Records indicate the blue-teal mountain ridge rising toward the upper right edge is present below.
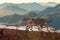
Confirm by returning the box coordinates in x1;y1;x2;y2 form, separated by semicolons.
39;4;60;15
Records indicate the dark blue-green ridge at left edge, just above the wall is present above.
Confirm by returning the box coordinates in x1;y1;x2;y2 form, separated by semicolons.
0;14;23;23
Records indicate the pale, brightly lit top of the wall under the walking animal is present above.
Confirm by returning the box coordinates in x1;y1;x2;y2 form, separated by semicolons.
0;25;60;33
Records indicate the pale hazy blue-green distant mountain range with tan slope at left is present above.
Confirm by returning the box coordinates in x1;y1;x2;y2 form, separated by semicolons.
0;2;57;16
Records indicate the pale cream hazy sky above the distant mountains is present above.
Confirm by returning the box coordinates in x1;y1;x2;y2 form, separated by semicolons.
0;0;60;3
